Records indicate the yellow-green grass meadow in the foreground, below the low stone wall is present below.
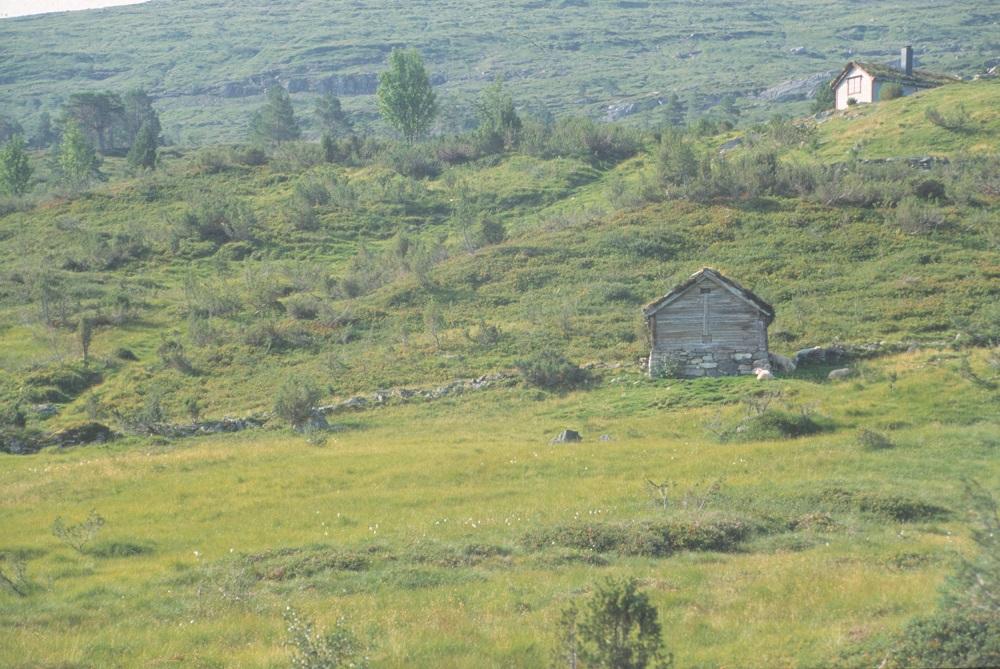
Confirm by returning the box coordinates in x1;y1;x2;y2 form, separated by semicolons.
0;350;1000;667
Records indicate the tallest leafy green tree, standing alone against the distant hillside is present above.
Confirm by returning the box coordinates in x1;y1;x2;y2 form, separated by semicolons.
378;49;438;143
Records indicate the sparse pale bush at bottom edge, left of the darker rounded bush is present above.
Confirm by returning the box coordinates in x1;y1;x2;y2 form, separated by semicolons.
285;607;368;669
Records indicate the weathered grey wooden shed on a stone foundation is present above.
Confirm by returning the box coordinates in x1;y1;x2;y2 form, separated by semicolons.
643;267;774;377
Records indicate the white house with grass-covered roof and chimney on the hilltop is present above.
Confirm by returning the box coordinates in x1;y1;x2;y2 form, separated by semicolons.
830;46;956;109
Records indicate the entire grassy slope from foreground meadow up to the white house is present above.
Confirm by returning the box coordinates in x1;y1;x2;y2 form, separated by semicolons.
0;74;1000;667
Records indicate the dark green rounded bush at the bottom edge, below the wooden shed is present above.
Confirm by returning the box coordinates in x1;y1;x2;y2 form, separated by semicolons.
555;578;673;669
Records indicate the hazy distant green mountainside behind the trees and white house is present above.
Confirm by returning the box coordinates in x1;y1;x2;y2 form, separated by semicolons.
0;0;1000;145
